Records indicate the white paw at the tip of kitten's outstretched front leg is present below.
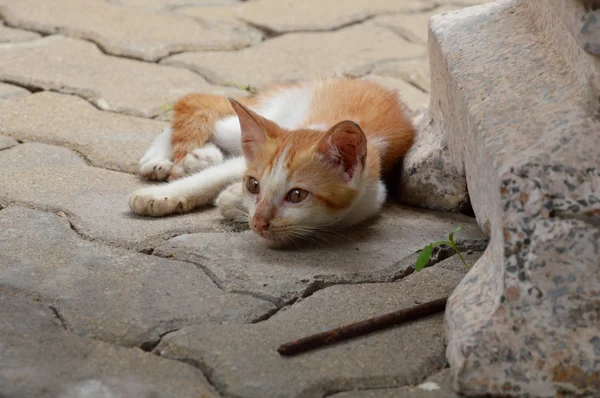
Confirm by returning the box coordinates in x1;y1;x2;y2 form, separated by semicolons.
129;185;194;217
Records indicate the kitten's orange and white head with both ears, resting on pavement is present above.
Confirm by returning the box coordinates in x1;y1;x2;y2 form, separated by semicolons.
232;100;367;243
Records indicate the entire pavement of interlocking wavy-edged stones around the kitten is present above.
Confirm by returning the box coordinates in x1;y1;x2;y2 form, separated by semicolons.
0;0;487;398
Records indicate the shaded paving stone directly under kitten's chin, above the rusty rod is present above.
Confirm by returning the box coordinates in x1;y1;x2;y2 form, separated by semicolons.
155;205;486;301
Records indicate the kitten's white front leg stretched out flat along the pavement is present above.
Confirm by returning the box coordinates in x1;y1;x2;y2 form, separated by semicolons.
129;157;246;217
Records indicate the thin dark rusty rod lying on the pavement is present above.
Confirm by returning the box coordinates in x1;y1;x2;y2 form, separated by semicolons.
277;297;448;357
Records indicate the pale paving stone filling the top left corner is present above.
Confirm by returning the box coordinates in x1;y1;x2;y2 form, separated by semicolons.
0;0;262;61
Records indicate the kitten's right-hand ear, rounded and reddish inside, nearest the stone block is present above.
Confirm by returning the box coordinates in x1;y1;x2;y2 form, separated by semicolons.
318;120;367;179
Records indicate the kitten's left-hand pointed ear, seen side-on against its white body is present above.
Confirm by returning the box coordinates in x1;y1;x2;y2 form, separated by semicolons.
229;98;278;161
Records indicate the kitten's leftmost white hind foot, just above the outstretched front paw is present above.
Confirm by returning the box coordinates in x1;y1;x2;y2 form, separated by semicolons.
139;128;173;181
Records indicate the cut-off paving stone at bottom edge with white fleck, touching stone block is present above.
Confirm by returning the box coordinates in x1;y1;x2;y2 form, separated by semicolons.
332;369;459;398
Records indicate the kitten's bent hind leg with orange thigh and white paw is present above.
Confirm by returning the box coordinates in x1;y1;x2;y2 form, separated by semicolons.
169;94;235;180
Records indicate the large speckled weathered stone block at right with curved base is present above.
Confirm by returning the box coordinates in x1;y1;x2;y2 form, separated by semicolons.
430;1;600;397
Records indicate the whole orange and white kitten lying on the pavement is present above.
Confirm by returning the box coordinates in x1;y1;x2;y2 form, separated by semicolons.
129;78;415;243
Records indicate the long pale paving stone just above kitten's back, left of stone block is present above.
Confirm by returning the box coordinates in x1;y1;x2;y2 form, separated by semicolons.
162;24;425;87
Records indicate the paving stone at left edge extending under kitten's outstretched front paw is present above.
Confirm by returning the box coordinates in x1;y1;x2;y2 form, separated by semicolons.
0;143;237;250
